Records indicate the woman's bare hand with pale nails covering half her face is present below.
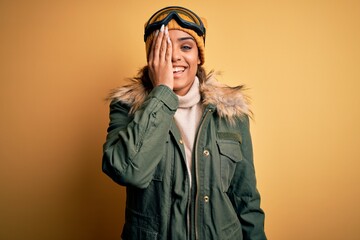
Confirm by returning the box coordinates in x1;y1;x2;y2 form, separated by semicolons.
148;25;174;89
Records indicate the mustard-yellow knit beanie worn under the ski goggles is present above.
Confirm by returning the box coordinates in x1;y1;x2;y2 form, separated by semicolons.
145;7;207;65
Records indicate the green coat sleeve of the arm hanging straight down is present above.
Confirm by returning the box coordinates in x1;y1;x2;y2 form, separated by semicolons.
228;117;266;240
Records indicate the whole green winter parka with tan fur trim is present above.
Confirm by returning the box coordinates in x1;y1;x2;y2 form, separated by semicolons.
102;77;266;240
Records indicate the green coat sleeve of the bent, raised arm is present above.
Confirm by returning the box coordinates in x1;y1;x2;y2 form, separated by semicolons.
102;85;178;188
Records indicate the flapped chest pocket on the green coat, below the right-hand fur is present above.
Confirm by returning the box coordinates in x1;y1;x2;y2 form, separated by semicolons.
217;140;243;192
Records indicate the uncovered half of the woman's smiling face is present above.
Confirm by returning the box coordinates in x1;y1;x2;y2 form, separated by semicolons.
169;30;200;96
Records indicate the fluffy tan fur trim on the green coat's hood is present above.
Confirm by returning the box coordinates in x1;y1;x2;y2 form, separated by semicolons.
108;74;252;122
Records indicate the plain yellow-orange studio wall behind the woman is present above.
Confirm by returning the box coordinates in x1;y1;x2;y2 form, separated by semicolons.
0;0;360;240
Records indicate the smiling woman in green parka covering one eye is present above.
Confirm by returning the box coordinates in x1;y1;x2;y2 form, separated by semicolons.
103;7;266;240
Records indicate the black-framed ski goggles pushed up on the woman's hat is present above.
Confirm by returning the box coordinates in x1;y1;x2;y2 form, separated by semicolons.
144;6;206;44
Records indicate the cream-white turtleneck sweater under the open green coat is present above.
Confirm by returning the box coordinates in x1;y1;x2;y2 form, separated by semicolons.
174;77;203;186
